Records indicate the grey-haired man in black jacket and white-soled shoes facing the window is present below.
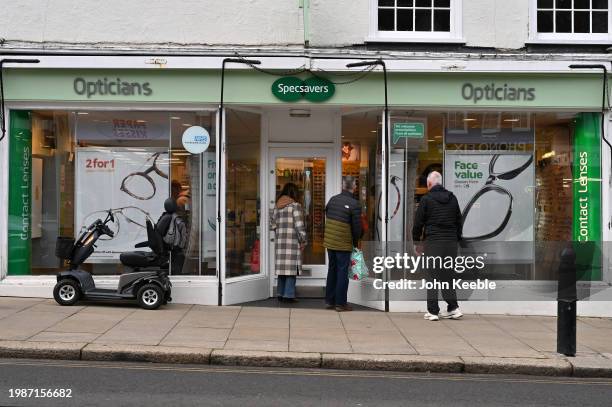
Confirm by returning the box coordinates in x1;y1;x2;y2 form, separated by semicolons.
412;171;463;321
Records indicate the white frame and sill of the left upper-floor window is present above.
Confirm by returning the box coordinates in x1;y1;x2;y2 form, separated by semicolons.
366;0;465;43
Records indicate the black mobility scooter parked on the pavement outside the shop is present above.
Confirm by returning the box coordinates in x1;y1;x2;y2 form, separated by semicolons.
53;210;172;310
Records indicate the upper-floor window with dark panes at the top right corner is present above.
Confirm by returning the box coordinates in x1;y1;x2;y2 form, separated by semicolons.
530;0;612;43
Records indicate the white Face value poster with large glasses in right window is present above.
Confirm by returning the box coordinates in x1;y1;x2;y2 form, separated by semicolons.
444;151;534;260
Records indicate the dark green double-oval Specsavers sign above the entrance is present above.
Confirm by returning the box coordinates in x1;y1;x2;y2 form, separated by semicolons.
272;76;336;102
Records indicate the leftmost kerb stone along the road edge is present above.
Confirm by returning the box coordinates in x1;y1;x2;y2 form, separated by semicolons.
0;341;86;360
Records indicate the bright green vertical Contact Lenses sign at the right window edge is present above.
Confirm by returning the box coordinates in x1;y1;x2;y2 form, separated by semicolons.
572;113;602;281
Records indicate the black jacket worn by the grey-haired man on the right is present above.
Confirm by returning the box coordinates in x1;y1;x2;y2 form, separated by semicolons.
412;185;462;242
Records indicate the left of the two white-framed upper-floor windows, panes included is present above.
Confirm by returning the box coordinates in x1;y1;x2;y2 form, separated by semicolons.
369;0;461;42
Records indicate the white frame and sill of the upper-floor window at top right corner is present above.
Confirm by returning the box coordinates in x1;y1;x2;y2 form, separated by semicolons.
528;0;612;44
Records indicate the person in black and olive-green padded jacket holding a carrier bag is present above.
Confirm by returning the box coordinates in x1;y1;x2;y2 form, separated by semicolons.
323;176;362;312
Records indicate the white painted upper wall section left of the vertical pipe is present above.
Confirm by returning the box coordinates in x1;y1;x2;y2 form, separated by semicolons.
0;0;304;45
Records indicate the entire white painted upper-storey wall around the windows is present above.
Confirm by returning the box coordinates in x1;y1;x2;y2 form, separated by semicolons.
0;0;529;49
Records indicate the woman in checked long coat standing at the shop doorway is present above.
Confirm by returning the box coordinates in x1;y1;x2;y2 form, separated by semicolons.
270;182;307;302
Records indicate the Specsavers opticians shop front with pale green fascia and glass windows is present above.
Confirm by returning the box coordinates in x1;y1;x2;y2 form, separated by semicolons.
0;57;610;314
